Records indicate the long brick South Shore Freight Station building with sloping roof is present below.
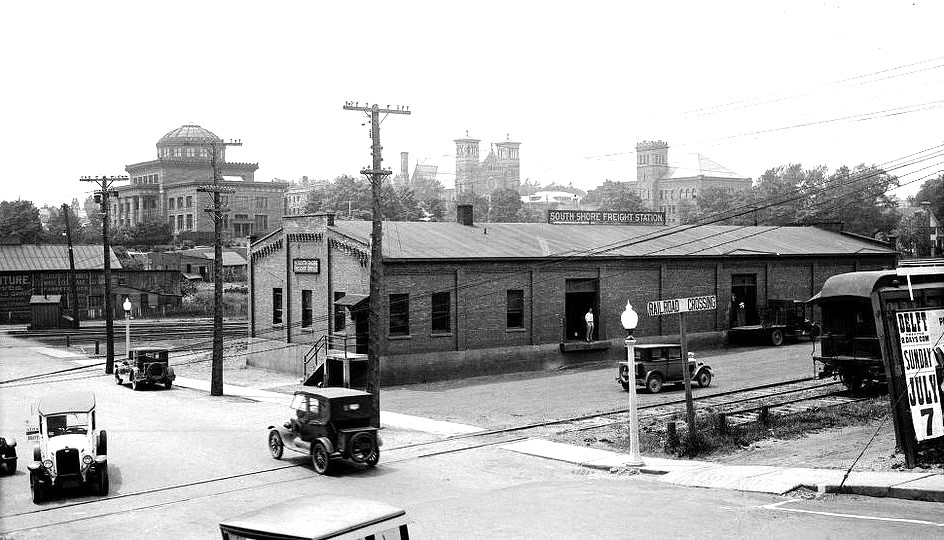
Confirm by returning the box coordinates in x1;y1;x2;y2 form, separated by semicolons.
249;207;897;384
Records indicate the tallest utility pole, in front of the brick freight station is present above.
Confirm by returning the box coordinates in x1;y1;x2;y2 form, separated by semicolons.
344;101;410;427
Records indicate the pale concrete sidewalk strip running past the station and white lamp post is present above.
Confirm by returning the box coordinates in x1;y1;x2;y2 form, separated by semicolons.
175;377;944;502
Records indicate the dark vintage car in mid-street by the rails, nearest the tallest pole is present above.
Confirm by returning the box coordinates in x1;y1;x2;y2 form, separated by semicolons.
268;387;381;474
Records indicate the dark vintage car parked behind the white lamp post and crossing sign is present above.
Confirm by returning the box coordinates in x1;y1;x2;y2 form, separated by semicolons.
616;343;714;394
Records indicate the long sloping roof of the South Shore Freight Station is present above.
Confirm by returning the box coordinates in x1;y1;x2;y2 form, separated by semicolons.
329;220;896;260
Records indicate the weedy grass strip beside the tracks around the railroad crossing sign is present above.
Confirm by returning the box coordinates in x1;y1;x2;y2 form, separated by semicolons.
581;396;888;458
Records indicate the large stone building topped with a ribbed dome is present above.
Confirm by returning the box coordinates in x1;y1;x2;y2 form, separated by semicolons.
110;124;288;243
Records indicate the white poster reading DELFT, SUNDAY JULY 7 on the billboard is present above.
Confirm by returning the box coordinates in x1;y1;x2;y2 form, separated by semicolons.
895;309;944;441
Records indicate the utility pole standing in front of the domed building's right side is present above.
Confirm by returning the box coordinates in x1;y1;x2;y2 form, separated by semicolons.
197;137;242;396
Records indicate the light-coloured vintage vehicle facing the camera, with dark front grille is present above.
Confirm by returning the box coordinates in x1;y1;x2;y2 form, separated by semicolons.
27;392;108;503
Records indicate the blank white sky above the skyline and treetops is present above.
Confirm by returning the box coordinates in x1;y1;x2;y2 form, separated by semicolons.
0;0;944;206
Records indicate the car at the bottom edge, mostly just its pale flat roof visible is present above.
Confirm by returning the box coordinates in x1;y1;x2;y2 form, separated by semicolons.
220;495;410;540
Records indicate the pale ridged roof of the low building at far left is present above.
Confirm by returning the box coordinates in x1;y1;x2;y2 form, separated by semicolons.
0;244;121;272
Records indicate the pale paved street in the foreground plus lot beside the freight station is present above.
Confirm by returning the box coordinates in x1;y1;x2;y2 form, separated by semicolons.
0;341;944;538
